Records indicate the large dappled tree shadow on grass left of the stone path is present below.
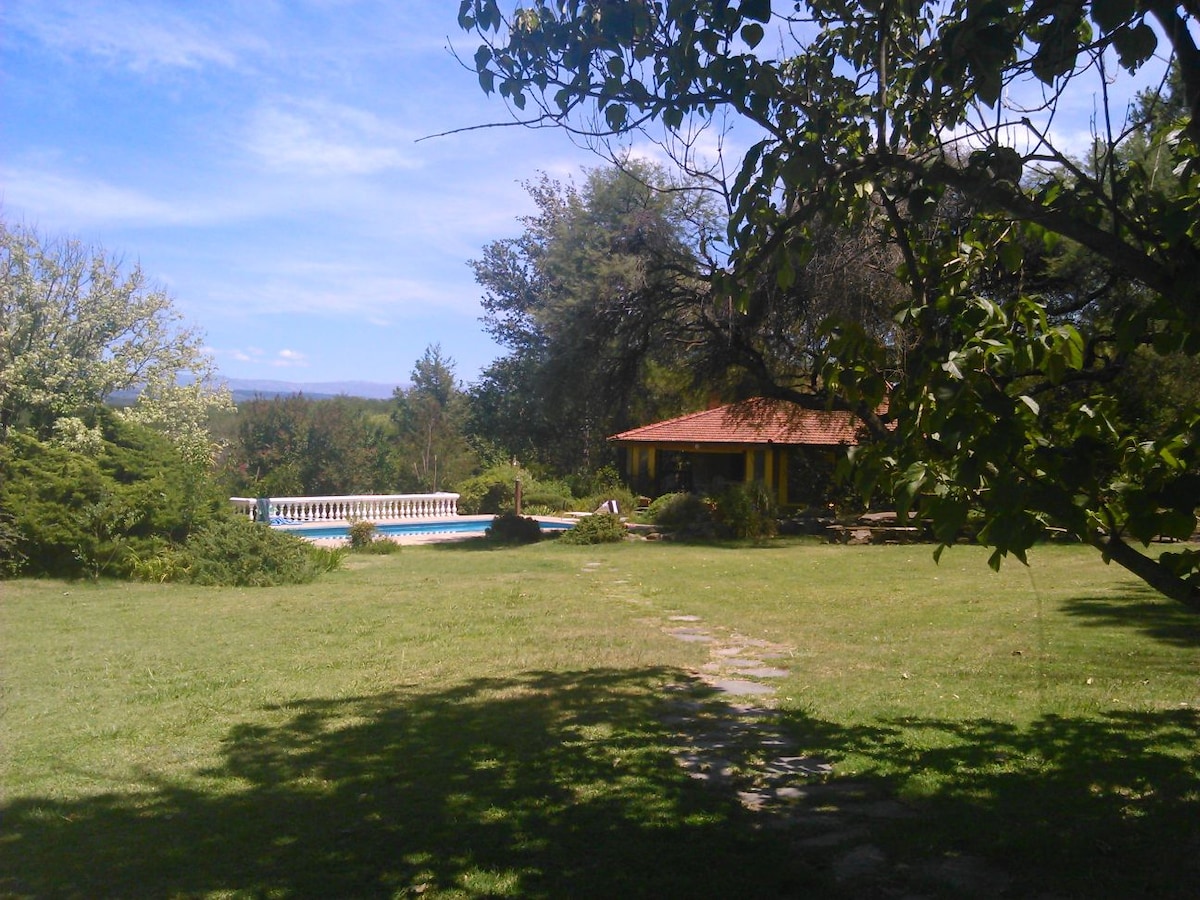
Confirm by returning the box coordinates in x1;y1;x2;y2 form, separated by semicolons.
0;670;828;898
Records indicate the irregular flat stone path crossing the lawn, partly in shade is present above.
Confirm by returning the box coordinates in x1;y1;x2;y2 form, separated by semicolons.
586;564;1010;900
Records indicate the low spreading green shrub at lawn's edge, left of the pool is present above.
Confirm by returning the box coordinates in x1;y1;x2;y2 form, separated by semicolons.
176;516;341;587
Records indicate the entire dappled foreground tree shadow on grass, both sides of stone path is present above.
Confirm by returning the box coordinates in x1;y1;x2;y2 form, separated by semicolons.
0;668;1200;898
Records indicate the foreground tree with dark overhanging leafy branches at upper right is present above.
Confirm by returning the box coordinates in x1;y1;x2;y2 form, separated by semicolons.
460;0;1200;610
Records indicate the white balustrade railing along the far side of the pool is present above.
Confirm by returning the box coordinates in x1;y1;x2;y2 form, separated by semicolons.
229;492;458;523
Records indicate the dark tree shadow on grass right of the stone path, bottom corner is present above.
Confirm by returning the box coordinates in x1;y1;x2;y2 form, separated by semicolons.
777;709;1200;898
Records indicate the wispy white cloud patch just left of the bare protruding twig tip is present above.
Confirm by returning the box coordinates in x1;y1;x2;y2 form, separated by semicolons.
246;101;420;175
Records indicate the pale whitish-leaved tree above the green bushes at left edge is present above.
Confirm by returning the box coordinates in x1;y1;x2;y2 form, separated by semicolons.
0;220;229;464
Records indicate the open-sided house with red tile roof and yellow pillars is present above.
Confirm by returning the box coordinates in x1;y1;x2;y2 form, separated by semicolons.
608;397;863;508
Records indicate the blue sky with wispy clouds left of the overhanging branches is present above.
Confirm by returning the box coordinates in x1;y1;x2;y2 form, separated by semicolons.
0;0;599;383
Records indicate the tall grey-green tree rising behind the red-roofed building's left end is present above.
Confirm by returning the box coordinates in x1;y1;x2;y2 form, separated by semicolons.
472;156;719;472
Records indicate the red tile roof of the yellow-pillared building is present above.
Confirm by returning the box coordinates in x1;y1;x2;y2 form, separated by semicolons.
608;397;862;446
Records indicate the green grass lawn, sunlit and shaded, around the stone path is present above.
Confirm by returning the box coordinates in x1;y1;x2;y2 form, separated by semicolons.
0;540;1200;898
